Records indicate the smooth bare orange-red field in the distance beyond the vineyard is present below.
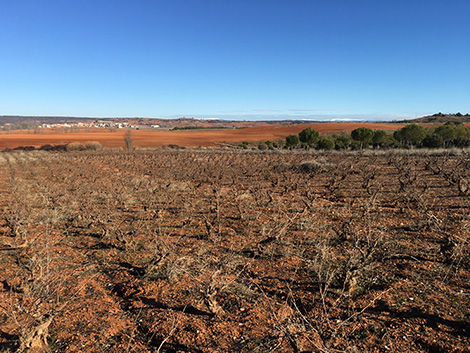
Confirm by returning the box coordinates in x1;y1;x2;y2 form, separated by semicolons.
0;123;403;150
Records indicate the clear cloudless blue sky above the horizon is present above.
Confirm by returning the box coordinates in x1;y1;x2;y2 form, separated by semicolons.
0;0;470;120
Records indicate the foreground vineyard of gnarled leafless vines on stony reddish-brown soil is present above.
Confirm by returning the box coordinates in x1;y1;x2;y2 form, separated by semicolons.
0;147;470;353
